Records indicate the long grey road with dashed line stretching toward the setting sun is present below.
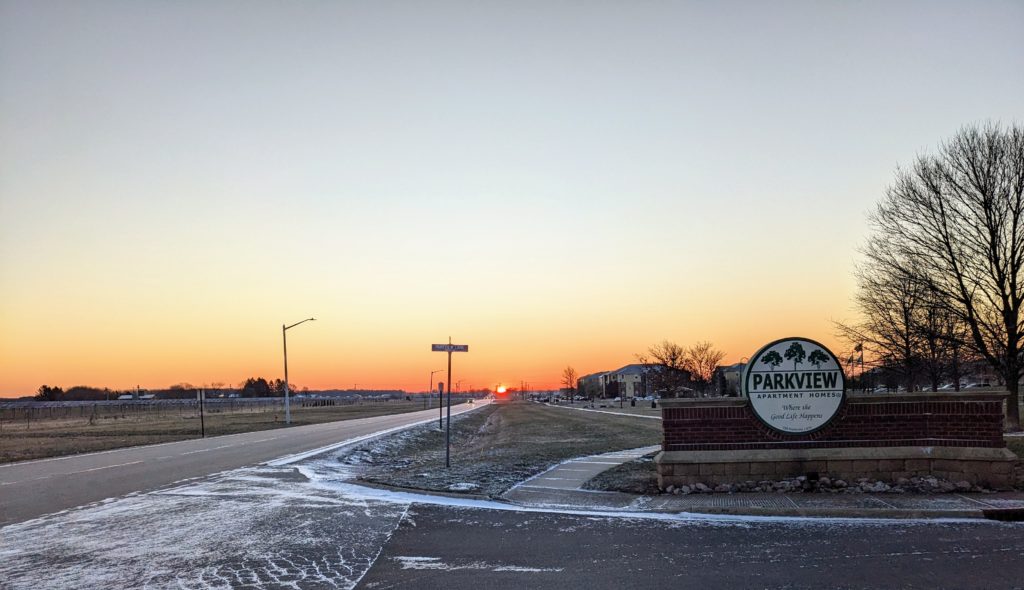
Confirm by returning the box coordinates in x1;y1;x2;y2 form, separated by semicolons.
0;404;480;526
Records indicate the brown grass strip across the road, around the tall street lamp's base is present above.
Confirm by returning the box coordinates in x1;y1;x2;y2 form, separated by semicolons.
0;401;446;463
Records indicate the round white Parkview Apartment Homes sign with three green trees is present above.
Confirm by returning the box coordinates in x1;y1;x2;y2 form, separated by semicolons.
743;338;846;434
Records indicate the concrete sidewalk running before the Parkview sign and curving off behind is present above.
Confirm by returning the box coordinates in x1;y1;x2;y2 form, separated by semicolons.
504;447;1024;519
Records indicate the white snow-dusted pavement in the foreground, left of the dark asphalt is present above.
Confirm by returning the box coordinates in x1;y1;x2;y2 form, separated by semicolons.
0;468;408;589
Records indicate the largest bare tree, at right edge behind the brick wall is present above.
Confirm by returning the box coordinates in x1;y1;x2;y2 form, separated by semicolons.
868;125;1024;430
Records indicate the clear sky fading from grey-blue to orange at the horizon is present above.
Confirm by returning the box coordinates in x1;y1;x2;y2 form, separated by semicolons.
0;0;1024;396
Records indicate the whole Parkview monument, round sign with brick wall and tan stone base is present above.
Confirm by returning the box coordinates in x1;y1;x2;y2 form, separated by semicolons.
654;338;1017;489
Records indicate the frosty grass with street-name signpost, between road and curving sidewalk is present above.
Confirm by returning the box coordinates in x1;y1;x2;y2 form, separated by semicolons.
350;403;662;496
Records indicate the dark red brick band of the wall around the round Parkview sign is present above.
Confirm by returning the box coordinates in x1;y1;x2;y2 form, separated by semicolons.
662;393;1006;451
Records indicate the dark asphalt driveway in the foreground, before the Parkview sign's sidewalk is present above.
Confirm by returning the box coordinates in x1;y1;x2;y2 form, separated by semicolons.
356;504;1024;590
